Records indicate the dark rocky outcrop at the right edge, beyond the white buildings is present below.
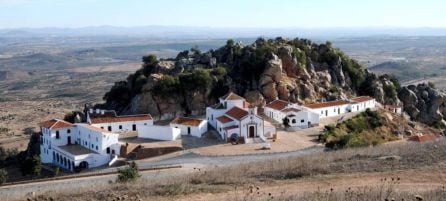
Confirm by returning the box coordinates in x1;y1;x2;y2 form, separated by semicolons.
398;84;446;127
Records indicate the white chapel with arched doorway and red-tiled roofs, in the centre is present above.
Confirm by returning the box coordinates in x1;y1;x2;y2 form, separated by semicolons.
206;92;276;142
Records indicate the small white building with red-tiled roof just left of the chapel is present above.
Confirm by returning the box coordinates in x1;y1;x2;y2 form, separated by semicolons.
170;117;208;137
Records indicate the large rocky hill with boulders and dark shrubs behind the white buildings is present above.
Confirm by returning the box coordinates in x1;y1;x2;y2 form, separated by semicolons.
99;37;446;127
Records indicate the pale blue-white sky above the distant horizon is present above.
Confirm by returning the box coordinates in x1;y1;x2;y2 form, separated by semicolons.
0;0;446;29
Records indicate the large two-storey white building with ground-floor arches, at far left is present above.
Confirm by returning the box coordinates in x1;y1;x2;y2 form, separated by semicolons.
40;119;121;171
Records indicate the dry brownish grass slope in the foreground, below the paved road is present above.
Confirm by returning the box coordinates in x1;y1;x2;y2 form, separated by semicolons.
19;139;446;201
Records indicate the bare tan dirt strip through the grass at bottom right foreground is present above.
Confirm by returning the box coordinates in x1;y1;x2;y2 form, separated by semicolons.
173;170;446;201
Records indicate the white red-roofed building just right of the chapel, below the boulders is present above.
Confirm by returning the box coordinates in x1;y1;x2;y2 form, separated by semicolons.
264;100;319;128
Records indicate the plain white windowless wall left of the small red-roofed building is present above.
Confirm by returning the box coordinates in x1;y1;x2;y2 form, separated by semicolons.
138;126;181;140
